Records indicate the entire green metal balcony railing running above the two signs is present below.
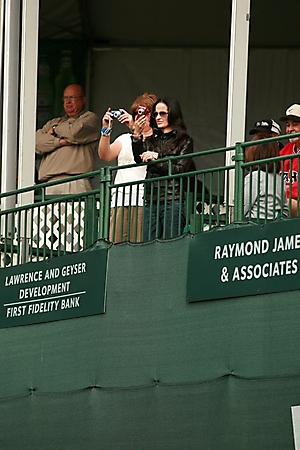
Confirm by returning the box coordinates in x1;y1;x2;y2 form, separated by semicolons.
0;133;300;267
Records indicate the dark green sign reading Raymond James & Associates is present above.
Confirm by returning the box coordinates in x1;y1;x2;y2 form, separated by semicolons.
187;219;300;302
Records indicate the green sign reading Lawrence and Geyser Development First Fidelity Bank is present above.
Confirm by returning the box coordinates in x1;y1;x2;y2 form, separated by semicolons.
0;249;107;328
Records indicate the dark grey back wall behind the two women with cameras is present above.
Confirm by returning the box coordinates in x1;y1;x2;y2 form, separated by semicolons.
90;48;300;190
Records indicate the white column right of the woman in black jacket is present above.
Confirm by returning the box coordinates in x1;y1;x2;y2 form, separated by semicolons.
225;0;251;206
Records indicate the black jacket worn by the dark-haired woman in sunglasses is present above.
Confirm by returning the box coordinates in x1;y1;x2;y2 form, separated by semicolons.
132;130;194;201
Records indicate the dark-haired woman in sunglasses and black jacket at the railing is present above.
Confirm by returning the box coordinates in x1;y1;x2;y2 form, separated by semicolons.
132;97;194;240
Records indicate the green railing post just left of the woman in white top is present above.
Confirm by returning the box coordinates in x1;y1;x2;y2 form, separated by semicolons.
99;167;112;239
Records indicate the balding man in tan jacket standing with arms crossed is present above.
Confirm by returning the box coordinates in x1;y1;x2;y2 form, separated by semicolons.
35;84;100;195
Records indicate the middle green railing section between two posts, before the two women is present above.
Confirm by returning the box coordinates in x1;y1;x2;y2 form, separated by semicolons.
105;147;234;242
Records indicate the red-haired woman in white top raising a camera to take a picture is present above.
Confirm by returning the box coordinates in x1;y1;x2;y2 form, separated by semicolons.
98;92;157;242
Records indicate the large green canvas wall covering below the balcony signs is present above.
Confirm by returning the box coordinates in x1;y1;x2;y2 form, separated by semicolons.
0;236;300;450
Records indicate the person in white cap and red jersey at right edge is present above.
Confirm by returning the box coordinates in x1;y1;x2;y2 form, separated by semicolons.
280;104;300;217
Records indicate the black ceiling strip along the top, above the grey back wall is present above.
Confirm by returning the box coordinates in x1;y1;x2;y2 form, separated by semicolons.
40;0;300;48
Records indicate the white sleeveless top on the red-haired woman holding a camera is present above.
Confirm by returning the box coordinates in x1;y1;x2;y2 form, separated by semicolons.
111;133;147;208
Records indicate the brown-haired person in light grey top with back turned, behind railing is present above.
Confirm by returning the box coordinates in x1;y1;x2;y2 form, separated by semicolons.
244;133;289;219
